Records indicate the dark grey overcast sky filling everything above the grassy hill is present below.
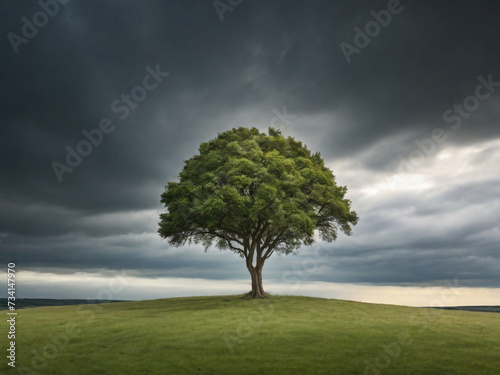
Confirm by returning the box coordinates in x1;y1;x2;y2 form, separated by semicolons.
0;0;500;305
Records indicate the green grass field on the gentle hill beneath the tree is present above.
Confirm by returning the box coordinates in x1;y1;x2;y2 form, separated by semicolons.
0;296;500;375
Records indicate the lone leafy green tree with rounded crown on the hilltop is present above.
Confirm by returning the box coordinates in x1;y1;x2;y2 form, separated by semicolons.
158;127;358;298
